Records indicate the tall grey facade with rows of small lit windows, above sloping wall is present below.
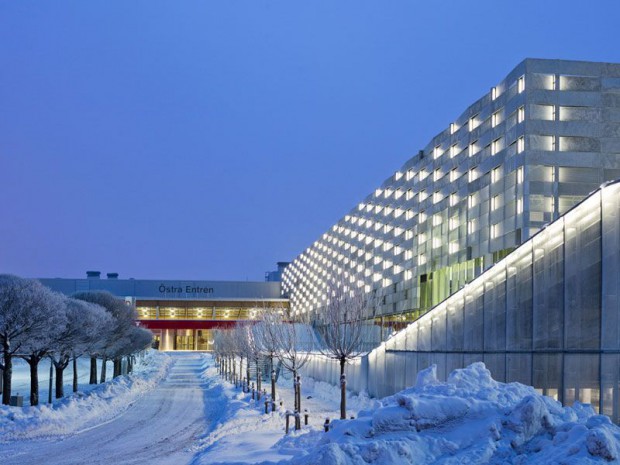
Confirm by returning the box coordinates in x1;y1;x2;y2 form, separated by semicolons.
283;59;620;325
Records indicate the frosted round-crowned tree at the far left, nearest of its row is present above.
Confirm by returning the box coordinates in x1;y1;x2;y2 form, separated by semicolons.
0;275;64;404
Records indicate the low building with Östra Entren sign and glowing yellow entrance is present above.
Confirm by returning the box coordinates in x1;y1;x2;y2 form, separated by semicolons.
39;271;288;350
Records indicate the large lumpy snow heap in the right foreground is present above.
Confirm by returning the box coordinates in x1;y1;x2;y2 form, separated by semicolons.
284;363;620;465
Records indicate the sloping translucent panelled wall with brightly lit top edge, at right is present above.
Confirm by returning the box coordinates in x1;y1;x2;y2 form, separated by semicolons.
308;183;620;422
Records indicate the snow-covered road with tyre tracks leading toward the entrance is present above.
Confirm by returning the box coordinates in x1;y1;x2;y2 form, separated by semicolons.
0;353;206;465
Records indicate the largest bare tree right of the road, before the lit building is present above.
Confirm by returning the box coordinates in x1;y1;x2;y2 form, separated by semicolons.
316;276;376;420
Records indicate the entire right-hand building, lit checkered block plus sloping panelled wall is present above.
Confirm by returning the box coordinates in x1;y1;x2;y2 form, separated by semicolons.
283;59;620;422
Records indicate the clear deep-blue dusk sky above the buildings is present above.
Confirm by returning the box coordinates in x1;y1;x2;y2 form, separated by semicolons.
0;0;620;280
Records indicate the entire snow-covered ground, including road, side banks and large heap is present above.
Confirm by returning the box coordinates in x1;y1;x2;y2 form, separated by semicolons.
0;352;620;465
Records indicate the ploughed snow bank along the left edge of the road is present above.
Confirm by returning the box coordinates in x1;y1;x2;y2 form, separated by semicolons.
0;351;172;442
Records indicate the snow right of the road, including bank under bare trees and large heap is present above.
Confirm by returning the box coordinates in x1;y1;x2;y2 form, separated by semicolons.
195;363;620;465
